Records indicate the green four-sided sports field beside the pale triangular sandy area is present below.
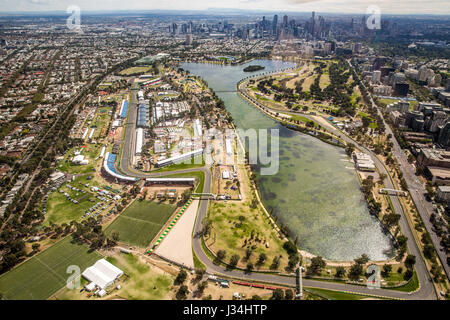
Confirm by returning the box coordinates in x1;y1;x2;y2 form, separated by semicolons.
105;200;175;248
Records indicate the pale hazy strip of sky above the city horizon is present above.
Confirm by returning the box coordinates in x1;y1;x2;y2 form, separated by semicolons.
0;0;450;14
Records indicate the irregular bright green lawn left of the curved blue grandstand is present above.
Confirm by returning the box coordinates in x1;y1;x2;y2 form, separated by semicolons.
43;183;99;226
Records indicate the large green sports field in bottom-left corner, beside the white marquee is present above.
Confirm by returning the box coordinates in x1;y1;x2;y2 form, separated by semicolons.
0;236;102;300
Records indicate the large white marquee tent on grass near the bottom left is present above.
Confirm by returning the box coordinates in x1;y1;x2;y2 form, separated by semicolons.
82;259;123;289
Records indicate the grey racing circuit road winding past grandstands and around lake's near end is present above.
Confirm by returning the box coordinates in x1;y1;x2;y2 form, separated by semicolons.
116;74;436;300
